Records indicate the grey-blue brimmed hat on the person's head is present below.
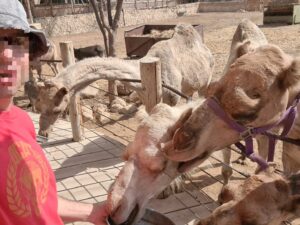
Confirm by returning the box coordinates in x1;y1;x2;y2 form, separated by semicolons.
0;0;49;58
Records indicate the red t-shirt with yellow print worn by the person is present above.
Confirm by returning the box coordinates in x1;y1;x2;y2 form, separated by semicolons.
0;106;63;225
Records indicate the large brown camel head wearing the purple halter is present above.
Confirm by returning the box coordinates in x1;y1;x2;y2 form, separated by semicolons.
164;45;300;161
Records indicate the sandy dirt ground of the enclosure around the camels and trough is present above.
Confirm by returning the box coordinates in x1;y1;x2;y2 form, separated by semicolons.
25;12;300;184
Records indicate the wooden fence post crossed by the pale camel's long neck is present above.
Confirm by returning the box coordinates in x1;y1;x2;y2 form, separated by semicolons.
59;41;83;141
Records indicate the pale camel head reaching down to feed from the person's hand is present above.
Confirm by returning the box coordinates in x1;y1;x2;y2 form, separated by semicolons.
108;103;205;225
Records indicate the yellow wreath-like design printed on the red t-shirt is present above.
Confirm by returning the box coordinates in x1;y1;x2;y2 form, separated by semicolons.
6;141;49;217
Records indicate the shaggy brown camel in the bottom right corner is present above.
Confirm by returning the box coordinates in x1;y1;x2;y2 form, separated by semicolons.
194;172;300;225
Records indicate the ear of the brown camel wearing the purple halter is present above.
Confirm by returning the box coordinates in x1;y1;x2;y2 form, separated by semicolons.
278;58;300;89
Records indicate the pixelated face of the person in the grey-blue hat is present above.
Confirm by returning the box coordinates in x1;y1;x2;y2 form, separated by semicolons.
0;28;29;98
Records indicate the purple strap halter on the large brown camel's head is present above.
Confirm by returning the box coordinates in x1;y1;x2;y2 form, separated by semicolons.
207;94;300;170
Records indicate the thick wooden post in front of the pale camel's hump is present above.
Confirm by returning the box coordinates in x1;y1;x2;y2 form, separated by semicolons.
140;57;162;113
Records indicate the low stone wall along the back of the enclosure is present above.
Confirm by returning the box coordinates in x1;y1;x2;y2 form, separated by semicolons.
35;0;261;37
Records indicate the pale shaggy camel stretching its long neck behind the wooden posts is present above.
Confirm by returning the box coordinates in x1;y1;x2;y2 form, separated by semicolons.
36;24;214;136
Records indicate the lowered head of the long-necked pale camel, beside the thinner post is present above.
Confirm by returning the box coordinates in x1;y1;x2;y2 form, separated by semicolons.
35;81;69;137
